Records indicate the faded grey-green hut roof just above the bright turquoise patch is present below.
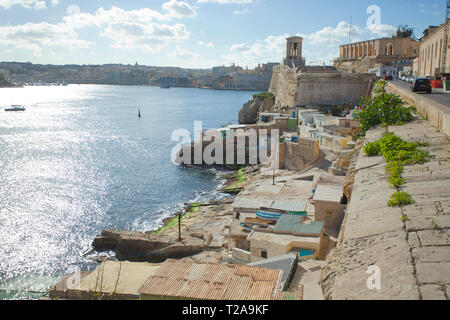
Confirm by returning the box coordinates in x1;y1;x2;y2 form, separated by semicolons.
273;215;324;237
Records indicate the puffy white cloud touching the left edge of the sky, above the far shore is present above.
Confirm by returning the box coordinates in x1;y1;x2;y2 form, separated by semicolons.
0;22;92;55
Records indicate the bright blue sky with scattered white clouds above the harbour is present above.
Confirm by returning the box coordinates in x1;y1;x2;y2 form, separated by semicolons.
0;0;446;68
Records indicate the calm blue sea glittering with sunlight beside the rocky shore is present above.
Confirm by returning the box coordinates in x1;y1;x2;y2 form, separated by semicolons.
0;85;253;298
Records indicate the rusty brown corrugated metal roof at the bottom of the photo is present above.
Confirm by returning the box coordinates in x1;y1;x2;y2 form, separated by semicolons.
139;259;283;300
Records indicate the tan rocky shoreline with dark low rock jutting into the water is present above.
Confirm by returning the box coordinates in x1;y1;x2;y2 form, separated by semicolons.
92;166;259;262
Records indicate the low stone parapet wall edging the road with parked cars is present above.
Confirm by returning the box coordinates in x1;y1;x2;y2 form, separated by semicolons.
387;82;450;136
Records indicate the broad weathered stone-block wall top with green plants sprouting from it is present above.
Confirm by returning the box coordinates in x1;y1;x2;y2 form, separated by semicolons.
322;120;450;299
